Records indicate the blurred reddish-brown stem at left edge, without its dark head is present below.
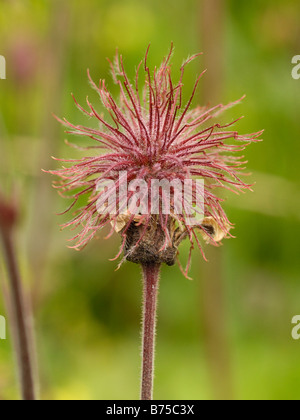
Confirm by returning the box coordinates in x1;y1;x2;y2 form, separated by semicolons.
2;229;36;401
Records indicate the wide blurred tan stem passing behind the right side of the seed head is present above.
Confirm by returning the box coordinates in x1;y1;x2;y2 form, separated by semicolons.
199;0;233;399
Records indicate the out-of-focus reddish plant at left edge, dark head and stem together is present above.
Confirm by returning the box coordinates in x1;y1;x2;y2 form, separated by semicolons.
0;195;36;400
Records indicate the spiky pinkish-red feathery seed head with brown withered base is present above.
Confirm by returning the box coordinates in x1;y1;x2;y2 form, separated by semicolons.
50;46;262;275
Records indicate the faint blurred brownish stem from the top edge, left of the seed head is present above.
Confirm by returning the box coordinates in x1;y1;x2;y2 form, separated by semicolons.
28;0;71;308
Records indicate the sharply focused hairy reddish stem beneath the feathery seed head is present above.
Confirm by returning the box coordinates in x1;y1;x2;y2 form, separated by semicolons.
141;264;160;400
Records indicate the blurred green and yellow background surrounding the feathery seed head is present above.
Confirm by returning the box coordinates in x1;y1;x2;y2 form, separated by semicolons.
0;0;300;399
